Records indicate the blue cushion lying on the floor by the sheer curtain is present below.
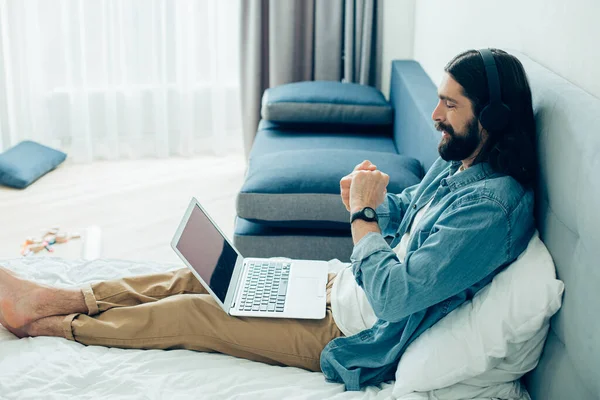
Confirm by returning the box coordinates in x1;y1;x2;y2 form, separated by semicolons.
0;140;67;189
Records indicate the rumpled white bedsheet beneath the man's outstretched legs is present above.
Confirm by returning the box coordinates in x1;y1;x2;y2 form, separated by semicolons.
0;258;398;400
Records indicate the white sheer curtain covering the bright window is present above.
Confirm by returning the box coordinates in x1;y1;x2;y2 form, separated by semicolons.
0;0;242;162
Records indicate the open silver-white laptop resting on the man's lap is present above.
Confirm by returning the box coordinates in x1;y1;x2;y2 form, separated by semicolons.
171;198;327;319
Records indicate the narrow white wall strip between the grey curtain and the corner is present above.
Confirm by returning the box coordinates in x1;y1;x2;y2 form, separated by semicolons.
381;0;415;97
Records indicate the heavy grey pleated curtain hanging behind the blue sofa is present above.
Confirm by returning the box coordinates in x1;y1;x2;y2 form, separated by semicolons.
239;0;382;155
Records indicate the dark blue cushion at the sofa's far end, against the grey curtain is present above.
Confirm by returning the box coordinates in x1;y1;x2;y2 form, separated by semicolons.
261;81;393;125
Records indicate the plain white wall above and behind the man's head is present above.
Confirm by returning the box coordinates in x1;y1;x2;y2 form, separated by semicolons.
410;0;600;98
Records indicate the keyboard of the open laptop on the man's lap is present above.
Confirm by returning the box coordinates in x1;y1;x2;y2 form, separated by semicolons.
238;261;291;313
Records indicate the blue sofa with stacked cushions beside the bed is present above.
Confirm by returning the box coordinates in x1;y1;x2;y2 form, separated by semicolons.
234;61;439;261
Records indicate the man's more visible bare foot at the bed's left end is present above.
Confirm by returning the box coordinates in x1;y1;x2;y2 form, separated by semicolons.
0;268;63;337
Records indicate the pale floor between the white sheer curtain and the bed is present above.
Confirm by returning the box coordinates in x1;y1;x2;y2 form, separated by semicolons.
0;154;245;264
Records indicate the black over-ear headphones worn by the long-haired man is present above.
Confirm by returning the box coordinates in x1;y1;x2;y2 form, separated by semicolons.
478;49;510;132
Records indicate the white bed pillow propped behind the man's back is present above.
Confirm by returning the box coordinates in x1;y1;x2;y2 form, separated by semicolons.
394;231;564;397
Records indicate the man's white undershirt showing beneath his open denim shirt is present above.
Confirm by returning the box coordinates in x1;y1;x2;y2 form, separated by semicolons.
330;170;460;336
